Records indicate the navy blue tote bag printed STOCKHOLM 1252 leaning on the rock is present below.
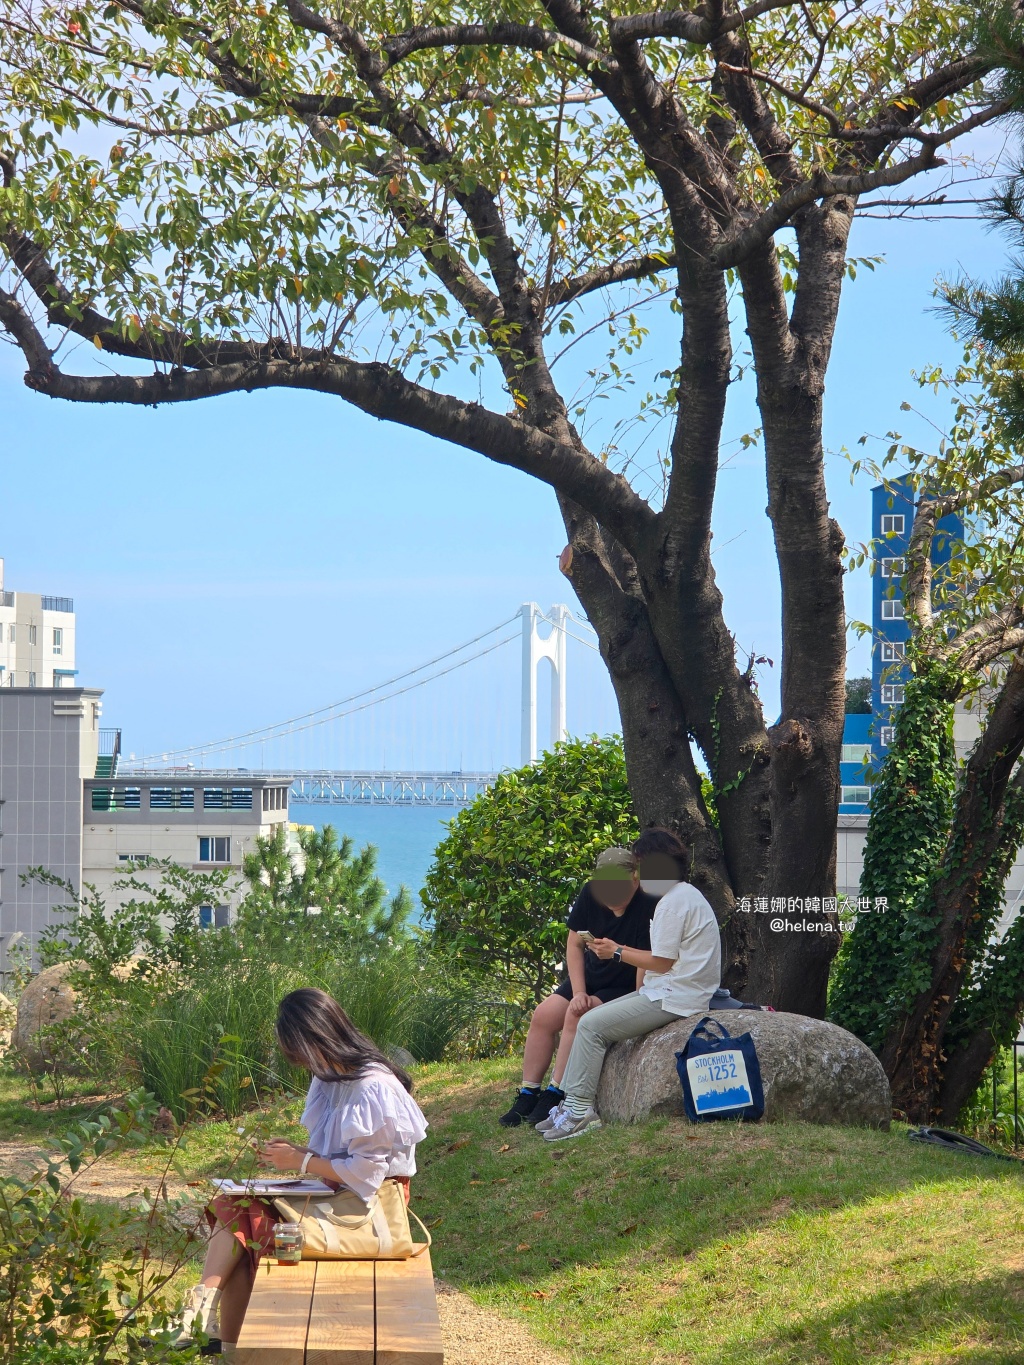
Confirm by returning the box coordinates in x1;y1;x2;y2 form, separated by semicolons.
676;1014;765;1123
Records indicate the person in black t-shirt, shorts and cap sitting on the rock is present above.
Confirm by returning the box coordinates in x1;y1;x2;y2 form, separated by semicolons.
498;848;658;1127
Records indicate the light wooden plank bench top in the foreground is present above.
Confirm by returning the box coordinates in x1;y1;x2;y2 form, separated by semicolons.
233;1252;444;1365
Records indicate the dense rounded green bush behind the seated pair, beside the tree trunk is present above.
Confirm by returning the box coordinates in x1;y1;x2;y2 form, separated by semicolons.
421;736;640;1009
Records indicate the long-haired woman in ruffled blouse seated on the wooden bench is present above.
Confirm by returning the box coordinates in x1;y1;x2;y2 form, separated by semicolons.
177;987;427;1354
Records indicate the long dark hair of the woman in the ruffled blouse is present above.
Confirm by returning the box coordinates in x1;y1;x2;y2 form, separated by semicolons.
274;986;412;1091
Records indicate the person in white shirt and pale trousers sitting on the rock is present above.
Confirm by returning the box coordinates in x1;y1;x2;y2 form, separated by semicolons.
537;829;722;1143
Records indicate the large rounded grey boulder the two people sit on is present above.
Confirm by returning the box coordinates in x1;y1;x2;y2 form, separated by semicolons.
597;1010;892;1127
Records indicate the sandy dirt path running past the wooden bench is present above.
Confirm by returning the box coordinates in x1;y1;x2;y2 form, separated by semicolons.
0;1143;567;1365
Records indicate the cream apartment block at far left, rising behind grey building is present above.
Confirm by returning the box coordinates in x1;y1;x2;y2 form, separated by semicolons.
0;560;76;688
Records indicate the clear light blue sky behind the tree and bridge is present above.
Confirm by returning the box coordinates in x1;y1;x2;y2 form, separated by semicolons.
0;150;1005;768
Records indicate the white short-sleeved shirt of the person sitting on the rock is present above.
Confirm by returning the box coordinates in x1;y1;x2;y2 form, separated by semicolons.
640;882;722;1014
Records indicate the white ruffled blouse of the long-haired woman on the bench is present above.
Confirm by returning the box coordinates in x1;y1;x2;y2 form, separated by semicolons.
302;1066;427;1200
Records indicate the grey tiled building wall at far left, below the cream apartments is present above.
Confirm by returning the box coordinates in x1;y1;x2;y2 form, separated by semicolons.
0;688;102;972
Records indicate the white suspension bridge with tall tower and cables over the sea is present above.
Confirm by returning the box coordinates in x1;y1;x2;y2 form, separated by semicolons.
117;602;617;808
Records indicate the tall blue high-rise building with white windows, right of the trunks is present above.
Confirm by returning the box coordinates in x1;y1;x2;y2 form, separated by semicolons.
840;478;964;815
